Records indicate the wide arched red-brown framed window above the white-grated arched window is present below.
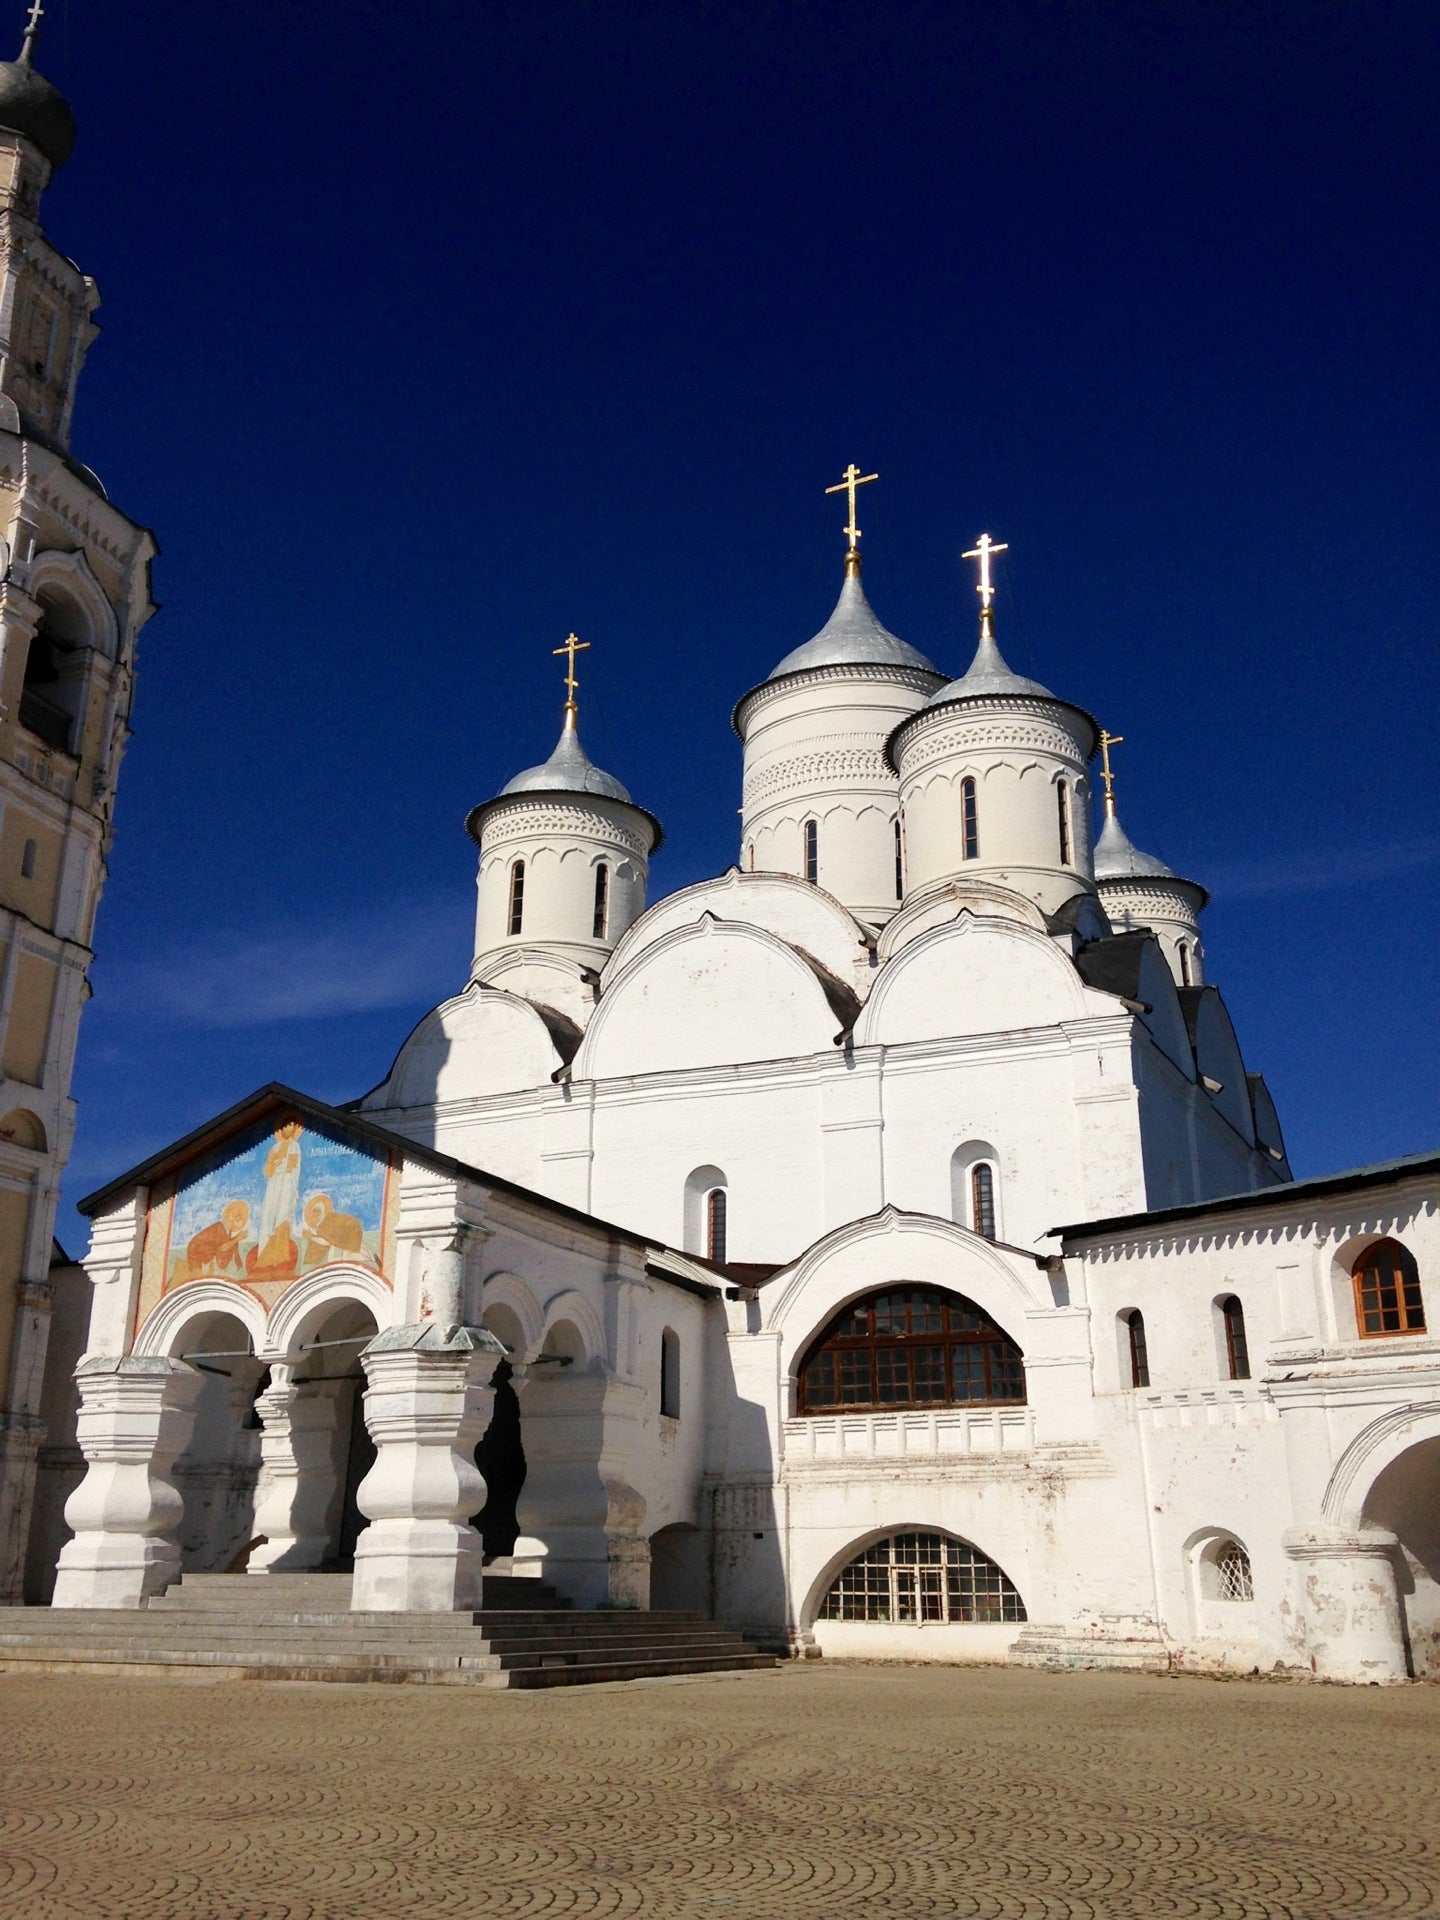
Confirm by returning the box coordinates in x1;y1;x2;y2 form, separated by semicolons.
795;1286;1025;1415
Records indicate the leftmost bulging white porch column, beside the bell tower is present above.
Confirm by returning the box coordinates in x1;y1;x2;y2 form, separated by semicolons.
50;1354;204;1607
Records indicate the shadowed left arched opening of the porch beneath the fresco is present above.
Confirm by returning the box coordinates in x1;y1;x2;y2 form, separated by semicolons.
173;1311;269;1572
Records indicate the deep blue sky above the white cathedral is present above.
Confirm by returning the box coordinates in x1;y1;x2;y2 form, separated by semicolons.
28;0;1440;1238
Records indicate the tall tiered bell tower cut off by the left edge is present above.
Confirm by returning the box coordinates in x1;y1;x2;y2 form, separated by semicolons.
0;11;156;1599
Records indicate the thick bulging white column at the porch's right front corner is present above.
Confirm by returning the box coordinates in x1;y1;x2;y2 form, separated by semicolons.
351;1321;505;1613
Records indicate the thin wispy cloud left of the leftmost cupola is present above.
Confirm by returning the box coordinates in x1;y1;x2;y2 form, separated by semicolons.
106;900;467;1027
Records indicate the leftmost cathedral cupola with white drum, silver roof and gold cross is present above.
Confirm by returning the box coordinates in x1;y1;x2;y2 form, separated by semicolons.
465;634;662;977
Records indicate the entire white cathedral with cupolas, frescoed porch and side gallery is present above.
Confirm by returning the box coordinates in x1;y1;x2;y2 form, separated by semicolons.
54;487;1440;1682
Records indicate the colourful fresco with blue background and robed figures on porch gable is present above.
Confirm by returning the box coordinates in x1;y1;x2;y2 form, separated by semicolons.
144;1117;394;1328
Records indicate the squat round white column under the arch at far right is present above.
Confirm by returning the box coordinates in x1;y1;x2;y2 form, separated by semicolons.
1283;1524;1409;1684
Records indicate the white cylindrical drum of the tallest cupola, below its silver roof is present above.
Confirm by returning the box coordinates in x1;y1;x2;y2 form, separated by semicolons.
735;664;939;924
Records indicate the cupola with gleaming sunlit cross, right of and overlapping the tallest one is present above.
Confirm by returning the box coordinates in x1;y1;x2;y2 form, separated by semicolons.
887;534;1098;914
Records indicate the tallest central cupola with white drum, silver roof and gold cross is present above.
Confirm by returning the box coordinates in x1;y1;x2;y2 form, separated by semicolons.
733;463;941;925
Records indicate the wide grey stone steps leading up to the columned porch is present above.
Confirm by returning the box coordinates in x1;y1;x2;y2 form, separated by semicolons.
0;1574;776;1688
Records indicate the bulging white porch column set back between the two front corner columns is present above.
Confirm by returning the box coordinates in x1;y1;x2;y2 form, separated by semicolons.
246;1367;340;1574
